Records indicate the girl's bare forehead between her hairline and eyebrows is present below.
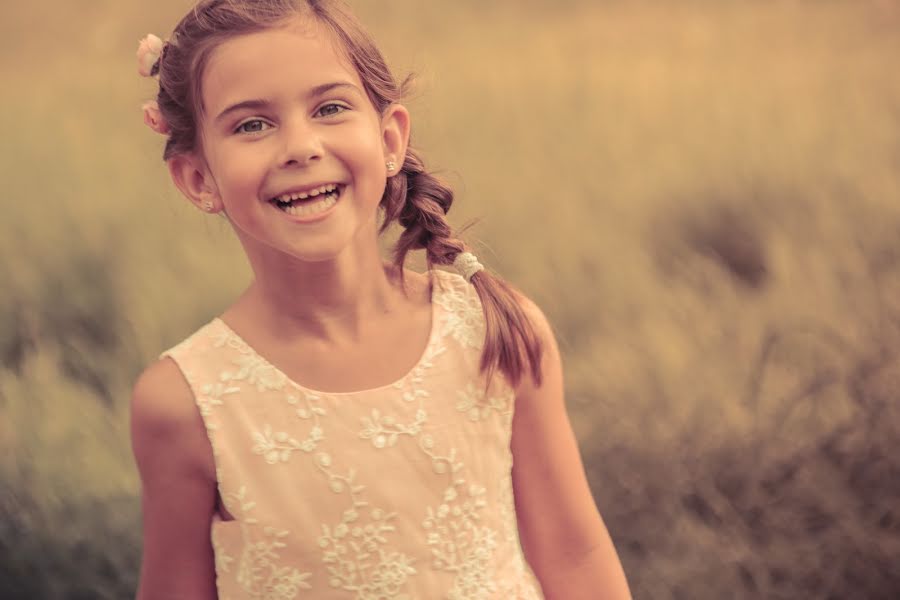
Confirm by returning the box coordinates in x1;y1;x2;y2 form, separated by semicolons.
201;24;362;116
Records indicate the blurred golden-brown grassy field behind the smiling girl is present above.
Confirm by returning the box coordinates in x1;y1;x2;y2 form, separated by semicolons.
0;0;900;600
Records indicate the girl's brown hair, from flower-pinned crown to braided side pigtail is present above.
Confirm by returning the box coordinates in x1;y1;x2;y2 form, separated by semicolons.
152;0;542;385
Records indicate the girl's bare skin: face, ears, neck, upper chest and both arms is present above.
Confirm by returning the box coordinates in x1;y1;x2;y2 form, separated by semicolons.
132;15;630;600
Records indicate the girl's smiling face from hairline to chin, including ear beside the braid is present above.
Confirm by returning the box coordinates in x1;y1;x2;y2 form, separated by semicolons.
200;22;409;262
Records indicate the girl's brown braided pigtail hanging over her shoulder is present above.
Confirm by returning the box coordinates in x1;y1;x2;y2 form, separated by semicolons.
381;148;543;386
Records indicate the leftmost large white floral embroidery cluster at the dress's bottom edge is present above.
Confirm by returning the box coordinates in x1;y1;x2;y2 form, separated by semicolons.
223;486;312;600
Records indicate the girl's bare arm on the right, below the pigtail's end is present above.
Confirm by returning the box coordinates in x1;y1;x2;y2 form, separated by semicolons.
511;297;631;600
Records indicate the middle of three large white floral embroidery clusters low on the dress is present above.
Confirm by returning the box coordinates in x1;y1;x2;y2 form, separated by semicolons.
316;452;416;600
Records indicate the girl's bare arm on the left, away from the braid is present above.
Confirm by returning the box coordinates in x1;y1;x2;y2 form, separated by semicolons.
131;359;217;600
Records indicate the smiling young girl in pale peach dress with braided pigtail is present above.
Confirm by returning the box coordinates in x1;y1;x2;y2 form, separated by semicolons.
132;0;629;600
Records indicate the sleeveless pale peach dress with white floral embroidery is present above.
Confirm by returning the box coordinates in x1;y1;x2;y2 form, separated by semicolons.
161;270;543;600
